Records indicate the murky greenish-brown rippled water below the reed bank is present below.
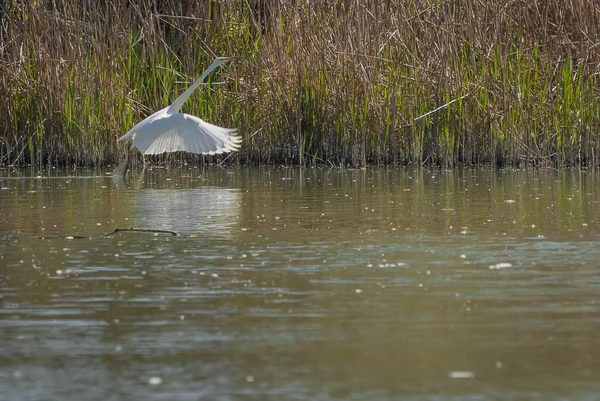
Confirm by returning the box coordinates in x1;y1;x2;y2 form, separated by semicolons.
0;168;600;400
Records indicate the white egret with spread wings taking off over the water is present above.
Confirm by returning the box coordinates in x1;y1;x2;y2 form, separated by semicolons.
117;57;242;175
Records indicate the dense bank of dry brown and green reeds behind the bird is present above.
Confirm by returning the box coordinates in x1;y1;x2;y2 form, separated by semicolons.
0;0;600;166
